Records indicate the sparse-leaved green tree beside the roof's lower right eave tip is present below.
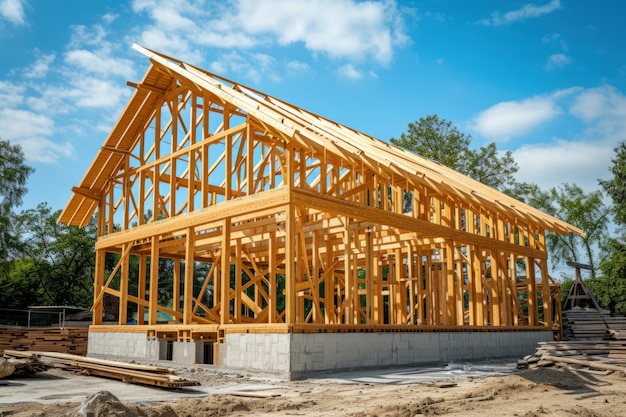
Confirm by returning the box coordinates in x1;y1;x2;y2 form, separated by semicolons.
528;183;610;278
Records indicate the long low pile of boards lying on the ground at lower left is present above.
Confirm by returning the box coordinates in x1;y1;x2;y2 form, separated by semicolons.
4;350;200;388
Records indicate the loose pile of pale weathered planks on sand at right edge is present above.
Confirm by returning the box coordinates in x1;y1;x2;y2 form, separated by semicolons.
518;331;626;375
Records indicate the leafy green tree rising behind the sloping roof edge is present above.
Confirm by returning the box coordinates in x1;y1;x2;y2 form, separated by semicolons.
390;115;520;194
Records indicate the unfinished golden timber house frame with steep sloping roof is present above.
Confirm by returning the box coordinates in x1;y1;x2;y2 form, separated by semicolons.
58;45;584;358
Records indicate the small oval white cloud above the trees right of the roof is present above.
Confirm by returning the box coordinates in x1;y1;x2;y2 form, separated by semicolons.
470;93;562;140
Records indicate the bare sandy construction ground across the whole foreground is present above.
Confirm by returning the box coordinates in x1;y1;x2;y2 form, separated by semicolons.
0;360;626;417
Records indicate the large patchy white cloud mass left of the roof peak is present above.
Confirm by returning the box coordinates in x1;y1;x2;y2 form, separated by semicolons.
0;15;135;164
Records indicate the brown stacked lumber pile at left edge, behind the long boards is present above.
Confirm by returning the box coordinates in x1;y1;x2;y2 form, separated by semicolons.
0;327;88;356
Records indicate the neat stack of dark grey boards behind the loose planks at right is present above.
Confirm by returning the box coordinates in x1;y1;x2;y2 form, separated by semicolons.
563;307;626;340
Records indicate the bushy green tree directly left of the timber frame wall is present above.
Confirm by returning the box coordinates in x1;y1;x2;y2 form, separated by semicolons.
15;203;96;307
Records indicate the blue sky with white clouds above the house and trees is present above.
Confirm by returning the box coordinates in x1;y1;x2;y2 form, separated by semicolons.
0;0;626;213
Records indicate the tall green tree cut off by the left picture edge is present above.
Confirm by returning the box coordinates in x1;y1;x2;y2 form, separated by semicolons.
0;140;34;264
